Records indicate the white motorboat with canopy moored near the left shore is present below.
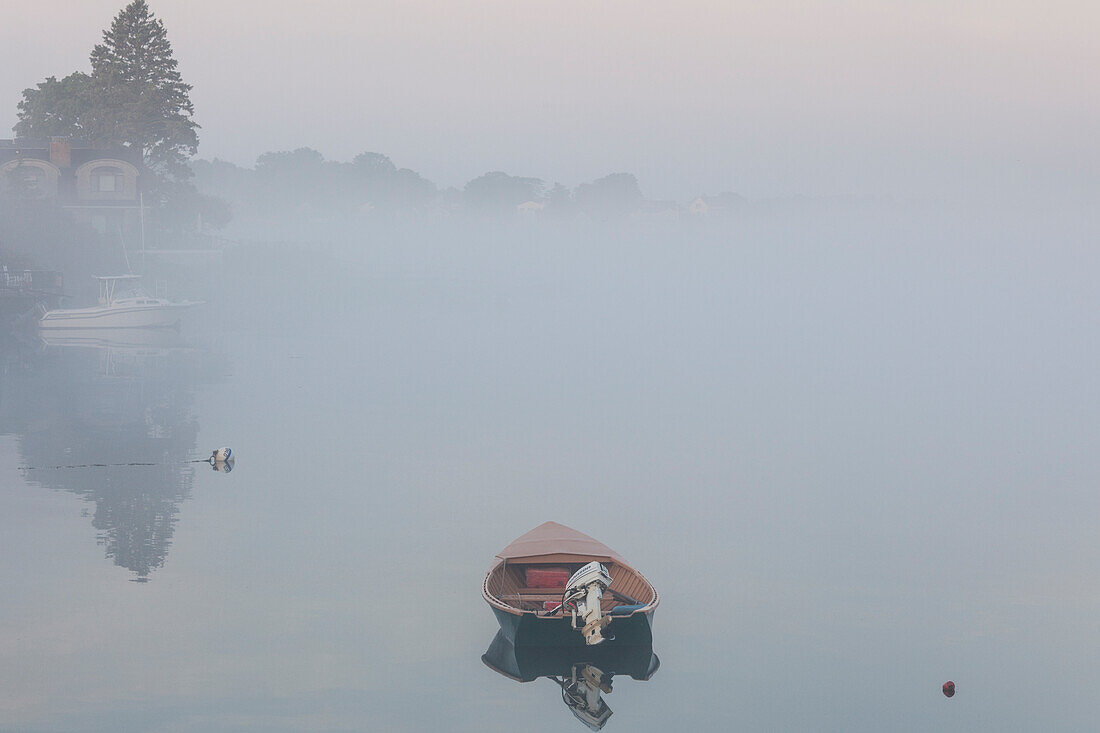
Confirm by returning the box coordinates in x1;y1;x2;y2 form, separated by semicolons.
39;275;199;328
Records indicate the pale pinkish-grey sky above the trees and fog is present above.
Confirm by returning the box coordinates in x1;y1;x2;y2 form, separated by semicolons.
0;0;1100;198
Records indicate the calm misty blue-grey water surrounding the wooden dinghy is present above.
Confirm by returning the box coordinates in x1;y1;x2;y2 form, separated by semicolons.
0;208;1100;733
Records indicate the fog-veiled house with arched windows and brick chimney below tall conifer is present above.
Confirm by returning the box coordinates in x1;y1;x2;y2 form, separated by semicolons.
0;138;142;237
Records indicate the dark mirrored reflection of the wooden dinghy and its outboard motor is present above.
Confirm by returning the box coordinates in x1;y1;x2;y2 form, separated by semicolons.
482;631;661;731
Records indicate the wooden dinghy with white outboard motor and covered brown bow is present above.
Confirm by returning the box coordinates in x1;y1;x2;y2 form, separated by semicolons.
482;522;659;647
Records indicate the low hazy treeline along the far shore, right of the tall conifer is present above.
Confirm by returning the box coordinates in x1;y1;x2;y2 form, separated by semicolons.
191;147;645;218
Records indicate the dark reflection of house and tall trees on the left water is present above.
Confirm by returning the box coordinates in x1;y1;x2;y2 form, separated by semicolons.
0;329;226;582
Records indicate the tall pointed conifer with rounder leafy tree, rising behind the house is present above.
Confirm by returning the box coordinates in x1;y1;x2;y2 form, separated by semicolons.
14;0;199;180
